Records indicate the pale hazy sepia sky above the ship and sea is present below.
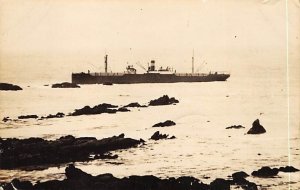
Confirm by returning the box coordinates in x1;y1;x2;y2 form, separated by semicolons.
0;0;300;82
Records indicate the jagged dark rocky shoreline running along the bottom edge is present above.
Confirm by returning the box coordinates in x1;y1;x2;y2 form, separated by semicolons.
1;164;299;190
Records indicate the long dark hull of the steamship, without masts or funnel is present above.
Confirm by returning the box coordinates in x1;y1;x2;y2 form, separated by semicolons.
72;73;230;84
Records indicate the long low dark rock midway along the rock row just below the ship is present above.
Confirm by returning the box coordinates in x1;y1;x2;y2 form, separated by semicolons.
71;103;118;116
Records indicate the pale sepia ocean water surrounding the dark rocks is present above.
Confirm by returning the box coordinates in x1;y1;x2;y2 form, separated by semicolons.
0;71;300;189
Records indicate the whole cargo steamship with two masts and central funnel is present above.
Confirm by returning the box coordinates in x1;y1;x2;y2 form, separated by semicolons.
72;55;230;84
